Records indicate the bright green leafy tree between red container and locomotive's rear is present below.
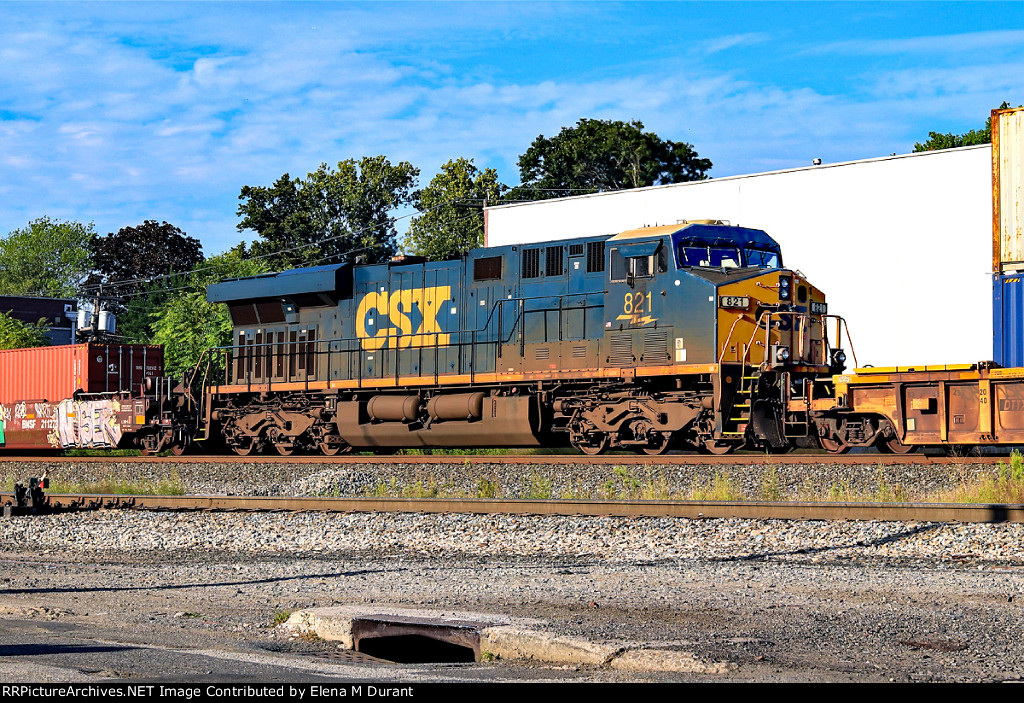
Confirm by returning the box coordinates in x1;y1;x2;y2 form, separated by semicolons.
153;244;268;377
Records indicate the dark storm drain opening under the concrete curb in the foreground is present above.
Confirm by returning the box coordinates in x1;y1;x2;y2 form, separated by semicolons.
352;615;483;664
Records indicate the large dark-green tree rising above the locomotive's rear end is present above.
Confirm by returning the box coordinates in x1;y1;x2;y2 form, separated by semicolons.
238;157;420;269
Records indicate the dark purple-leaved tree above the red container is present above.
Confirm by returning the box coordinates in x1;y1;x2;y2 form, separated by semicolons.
89;220;203;296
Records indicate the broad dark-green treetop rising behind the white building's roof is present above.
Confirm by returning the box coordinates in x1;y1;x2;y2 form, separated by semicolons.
513;119;712;200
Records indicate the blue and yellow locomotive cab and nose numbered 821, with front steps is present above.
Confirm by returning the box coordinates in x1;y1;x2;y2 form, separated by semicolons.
605;221;845;452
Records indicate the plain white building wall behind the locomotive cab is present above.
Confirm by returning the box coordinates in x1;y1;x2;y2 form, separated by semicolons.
487;145;992;366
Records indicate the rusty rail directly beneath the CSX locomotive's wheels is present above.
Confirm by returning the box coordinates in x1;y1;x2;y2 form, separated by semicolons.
0;452;1009;466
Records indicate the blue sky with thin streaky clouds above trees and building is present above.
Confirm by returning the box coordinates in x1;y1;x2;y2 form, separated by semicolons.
0;2;1024;254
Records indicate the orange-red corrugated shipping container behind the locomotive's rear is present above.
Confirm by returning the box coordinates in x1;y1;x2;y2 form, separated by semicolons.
0;344;164;403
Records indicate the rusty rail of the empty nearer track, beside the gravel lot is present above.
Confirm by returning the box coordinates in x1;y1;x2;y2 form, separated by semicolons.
8;493;1024;523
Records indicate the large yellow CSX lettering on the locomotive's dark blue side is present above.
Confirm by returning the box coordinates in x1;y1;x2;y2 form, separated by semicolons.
355;285;452;351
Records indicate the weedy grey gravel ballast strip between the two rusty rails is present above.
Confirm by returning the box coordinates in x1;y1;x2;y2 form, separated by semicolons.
0;456;997;500
